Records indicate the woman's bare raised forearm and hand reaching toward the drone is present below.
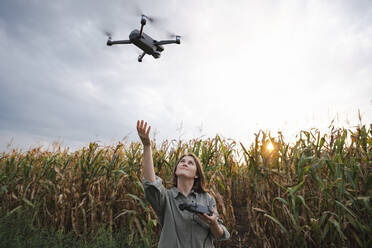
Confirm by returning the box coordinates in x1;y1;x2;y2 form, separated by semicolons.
137;120;155;182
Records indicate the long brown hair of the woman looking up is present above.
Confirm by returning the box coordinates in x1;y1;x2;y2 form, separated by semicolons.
173;152;209;193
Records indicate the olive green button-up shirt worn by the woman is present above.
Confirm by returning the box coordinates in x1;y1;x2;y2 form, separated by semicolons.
143;176;230;248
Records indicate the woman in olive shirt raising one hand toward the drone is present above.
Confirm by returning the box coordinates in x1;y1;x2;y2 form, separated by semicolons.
137;120;230;248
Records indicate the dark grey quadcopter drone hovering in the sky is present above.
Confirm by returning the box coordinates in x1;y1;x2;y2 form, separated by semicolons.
107;15;181;62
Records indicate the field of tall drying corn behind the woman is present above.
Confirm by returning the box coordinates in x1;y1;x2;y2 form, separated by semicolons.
0;125;372;247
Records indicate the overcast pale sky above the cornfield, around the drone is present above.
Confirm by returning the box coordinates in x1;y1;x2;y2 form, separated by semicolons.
0;0;372;151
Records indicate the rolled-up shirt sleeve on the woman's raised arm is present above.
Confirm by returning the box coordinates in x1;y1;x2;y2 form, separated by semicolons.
142;176;166;225
